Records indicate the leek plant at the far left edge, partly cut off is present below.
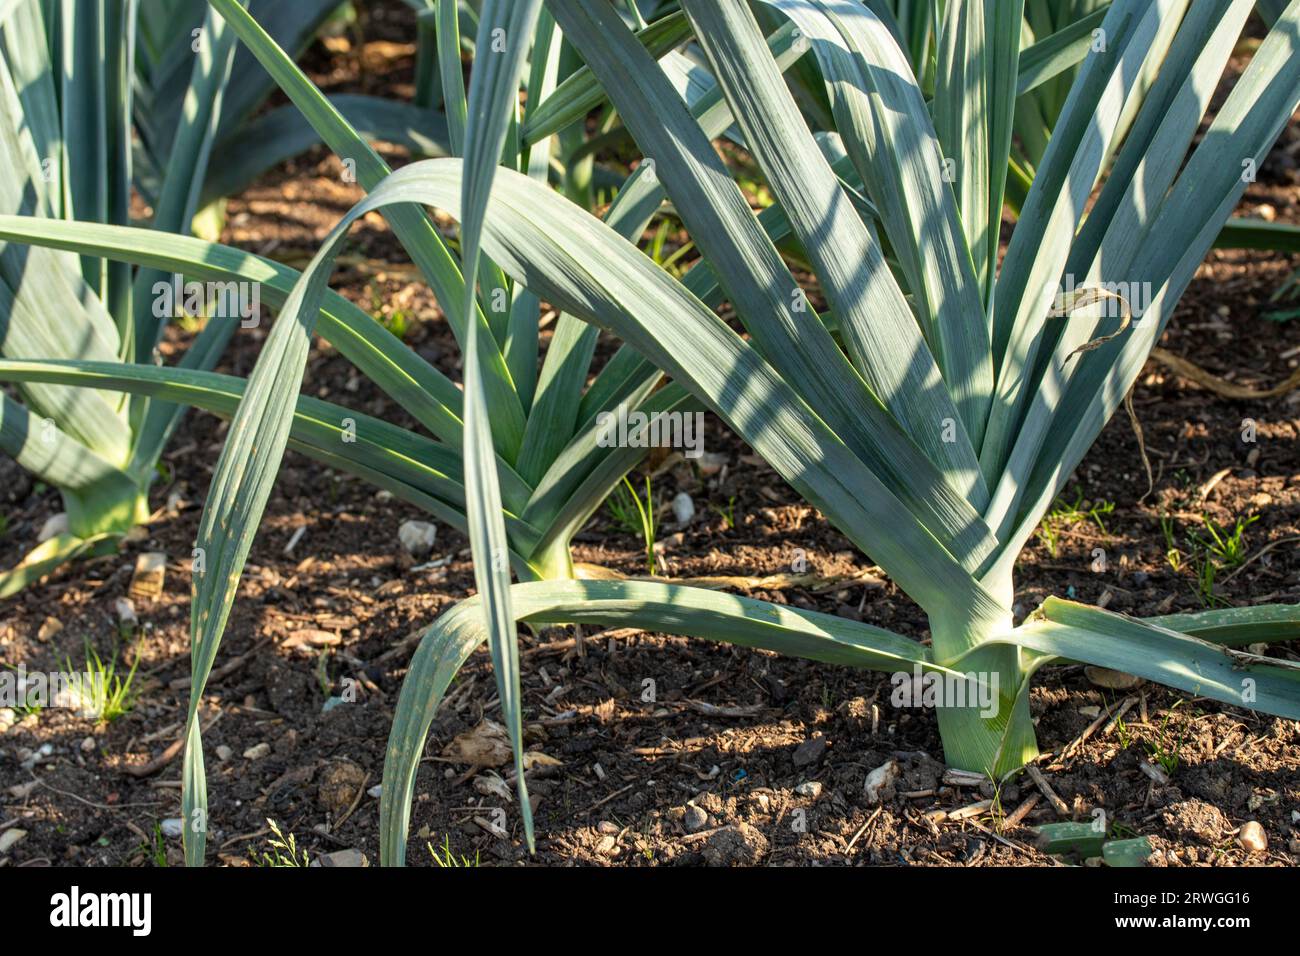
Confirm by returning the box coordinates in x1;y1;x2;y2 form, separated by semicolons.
0;0;234;596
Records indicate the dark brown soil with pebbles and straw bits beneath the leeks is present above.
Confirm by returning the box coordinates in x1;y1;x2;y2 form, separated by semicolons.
0;3;1300;866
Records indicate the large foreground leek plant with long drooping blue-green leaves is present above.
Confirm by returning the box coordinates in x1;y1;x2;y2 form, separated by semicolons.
0;0;1300;864
